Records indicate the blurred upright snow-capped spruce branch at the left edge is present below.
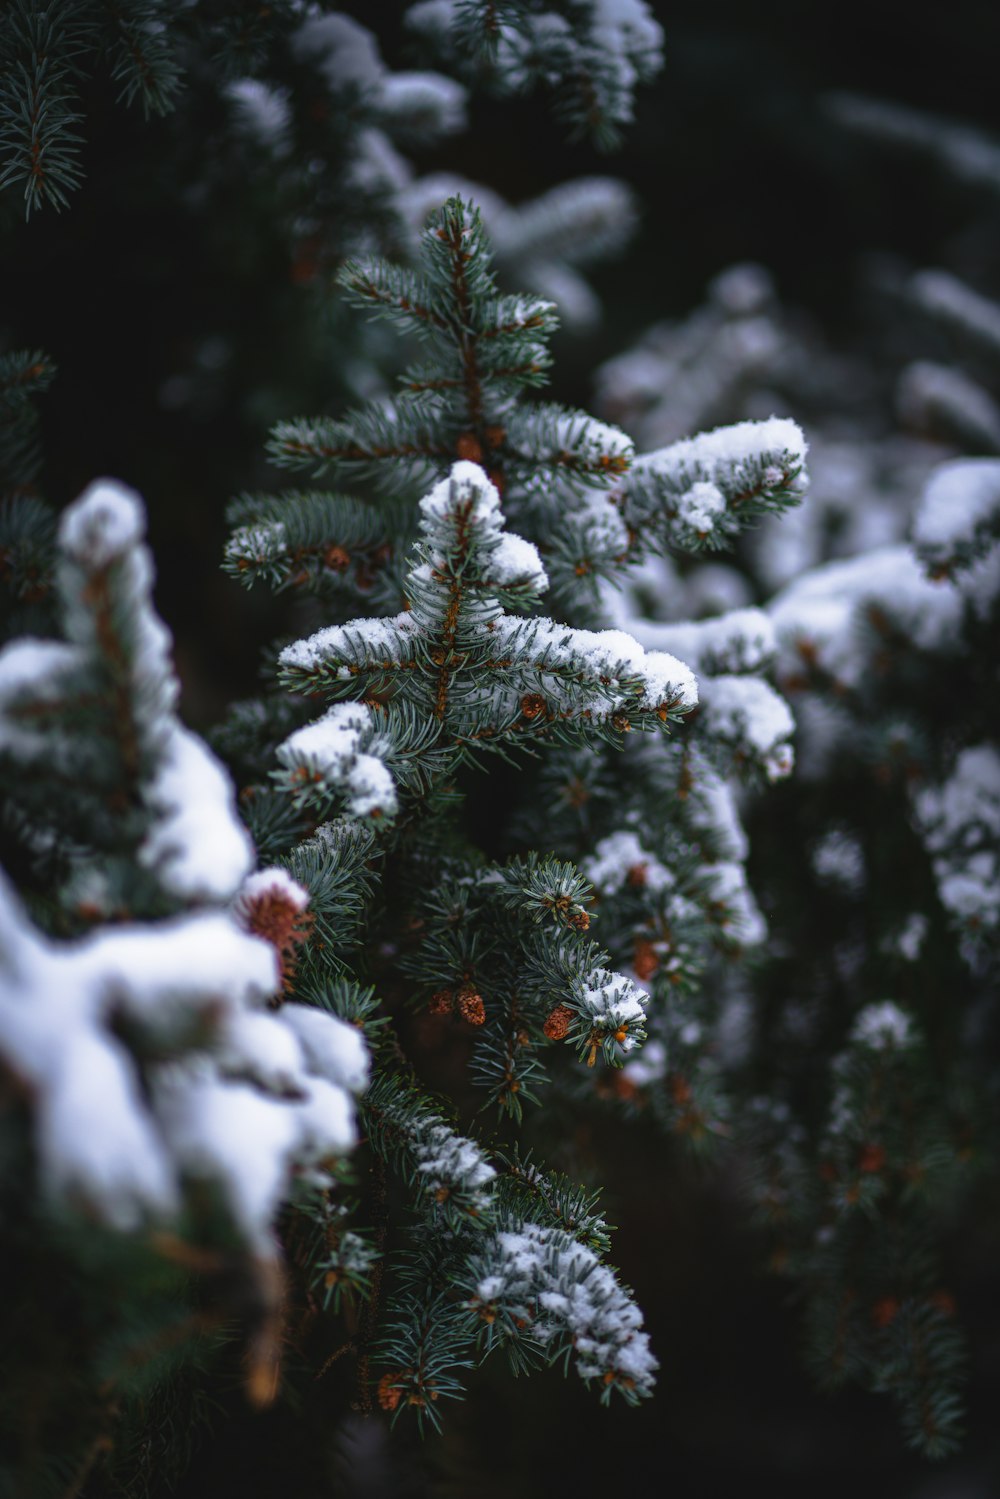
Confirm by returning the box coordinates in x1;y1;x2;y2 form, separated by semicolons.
0;480;252;913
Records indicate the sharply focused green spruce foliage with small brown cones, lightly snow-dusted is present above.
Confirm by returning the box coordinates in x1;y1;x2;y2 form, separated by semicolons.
220;198;804;1426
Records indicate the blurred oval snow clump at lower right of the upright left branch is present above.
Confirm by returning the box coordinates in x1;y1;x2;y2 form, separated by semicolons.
139;723;253;901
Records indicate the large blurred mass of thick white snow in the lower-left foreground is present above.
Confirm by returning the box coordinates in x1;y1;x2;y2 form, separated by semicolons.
0;880;367;1250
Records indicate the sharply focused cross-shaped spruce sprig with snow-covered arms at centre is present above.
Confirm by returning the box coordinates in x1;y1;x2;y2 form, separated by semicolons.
280;462;697;779
